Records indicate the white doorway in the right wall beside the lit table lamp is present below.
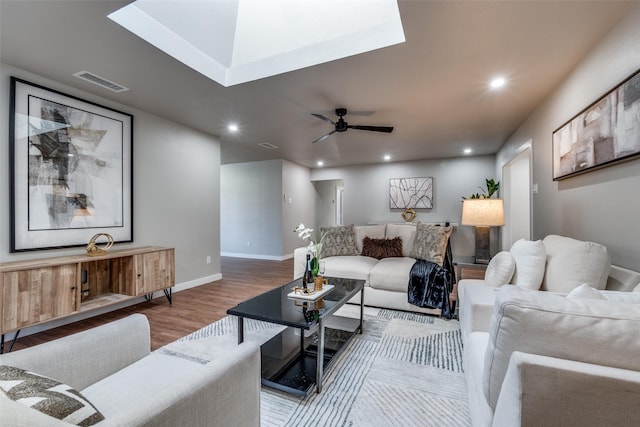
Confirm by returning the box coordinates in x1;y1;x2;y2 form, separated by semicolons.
502;144;533;250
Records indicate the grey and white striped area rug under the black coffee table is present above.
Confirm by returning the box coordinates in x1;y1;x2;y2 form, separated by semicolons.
157;305;471;427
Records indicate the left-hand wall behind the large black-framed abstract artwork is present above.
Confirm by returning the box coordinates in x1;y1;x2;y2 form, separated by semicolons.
0;64;221;286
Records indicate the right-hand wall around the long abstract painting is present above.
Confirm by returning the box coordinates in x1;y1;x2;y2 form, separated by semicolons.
496;3;640;270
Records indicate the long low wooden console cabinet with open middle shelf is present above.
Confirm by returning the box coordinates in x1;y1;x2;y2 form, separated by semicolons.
0;247;175;341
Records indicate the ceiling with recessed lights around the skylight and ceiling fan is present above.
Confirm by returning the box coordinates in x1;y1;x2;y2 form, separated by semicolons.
0;0;637;167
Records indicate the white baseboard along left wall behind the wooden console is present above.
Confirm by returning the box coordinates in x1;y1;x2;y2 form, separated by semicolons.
5;273;222;342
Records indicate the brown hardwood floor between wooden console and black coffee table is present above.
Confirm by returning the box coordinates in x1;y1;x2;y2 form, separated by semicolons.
5;257;293;351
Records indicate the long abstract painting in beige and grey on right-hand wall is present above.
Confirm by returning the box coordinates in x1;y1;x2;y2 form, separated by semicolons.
552;71;640;181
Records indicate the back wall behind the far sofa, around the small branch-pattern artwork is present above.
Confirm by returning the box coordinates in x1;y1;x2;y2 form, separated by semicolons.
311;156;499;255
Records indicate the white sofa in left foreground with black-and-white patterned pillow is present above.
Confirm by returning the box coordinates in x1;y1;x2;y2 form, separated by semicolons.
0;314;260;427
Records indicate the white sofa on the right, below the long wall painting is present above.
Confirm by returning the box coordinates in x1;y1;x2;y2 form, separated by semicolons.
458;236;640;426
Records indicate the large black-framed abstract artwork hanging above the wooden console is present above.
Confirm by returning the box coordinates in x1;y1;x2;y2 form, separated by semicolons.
9;77;133;252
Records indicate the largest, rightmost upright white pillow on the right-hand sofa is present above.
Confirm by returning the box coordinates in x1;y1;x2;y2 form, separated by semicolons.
542;235;611;293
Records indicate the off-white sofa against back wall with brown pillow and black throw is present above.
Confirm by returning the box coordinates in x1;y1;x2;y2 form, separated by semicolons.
293;223;452;315
